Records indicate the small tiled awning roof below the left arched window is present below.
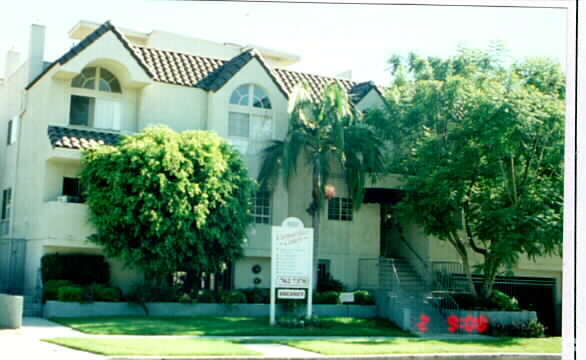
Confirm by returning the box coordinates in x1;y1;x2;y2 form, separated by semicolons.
47;126;120;150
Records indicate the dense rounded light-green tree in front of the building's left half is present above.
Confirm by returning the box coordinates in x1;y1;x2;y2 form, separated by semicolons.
81;127;254;282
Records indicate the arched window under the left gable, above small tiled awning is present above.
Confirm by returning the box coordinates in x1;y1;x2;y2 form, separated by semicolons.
69;67;122;130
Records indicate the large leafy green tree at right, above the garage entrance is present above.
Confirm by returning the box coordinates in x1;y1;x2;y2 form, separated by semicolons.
369;50;564;298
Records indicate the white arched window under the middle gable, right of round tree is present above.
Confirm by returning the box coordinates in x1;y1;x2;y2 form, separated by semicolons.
228;84;273;154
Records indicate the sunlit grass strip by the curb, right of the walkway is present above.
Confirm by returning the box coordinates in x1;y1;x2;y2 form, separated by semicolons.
283;337;562;355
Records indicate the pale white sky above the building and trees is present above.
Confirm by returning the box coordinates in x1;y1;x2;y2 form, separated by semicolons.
0;0;566;85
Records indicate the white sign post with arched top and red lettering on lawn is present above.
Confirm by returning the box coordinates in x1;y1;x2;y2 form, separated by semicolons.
271;217;313;325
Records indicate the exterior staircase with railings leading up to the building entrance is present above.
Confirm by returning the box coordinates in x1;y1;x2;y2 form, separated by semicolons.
377;258;458;336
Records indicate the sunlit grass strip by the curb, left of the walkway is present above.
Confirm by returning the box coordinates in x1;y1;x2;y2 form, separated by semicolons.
43;338;259;356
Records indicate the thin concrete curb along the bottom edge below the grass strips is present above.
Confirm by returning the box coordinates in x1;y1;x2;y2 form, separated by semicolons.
105;353;562;360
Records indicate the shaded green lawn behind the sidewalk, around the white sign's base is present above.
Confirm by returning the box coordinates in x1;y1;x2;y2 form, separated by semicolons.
51;317;411;337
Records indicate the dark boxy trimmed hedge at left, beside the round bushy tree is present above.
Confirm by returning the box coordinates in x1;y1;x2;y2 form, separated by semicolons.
41;254;110;285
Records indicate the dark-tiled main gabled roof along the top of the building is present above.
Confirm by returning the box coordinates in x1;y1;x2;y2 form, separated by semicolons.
26;21;382;103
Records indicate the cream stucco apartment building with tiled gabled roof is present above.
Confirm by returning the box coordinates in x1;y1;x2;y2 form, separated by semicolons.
0;21;562;332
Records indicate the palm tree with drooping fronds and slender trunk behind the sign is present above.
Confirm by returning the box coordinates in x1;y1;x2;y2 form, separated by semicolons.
259;83;384;284
